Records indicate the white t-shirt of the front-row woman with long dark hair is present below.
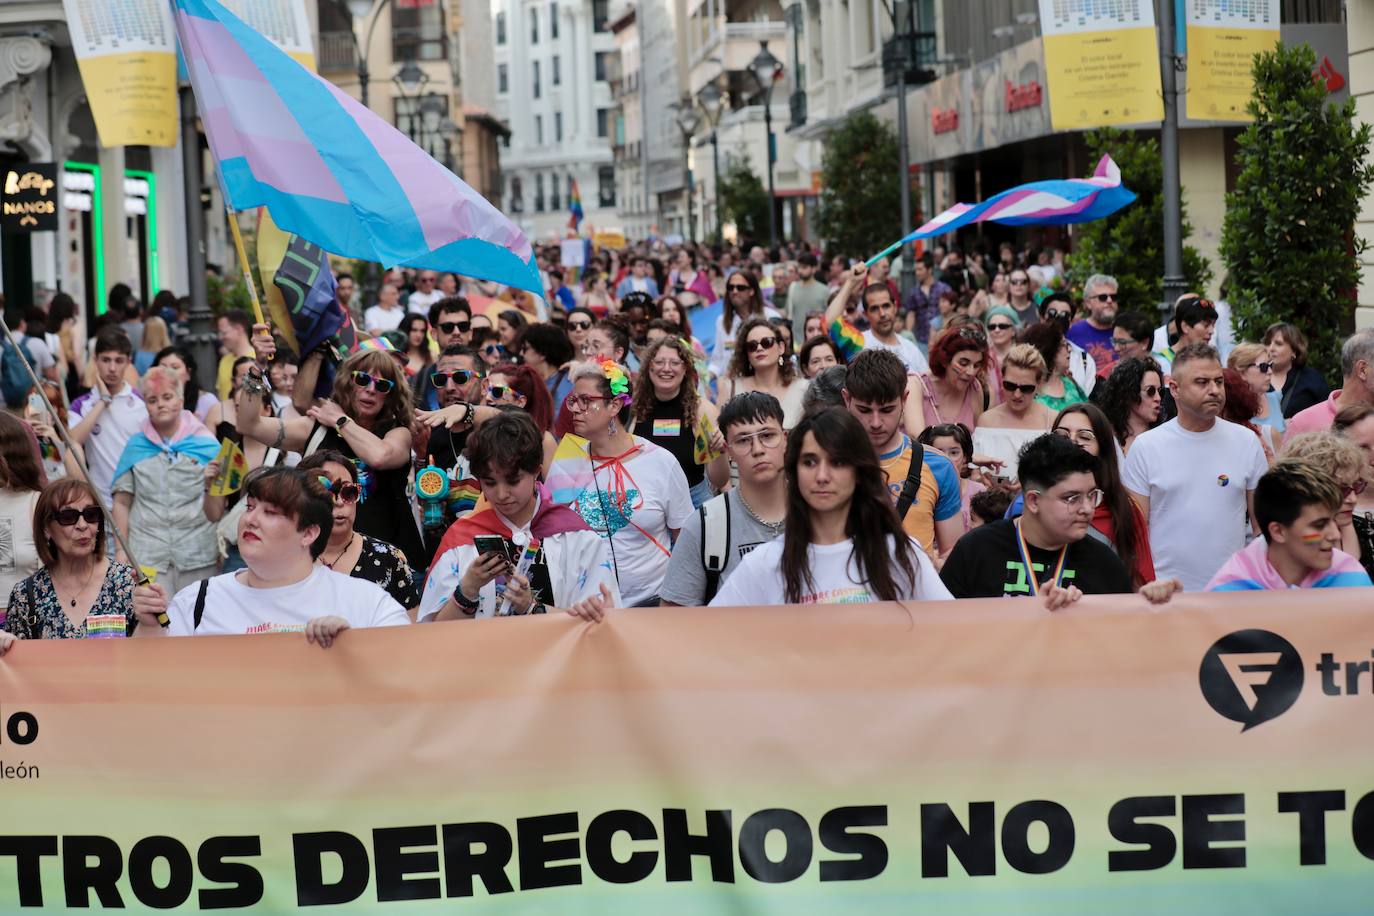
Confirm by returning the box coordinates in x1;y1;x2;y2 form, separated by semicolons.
710;537;954;607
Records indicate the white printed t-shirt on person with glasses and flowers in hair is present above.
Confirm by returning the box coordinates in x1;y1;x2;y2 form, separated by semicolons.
577;435;692;607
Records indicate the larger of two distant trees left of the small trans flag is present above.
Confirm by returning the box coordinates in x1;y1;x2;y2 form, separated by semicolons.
816;111;901;257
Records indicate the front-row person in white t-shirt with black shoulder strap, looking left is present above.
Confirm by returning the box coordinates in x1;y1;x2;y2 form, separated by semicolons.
133;467;409;648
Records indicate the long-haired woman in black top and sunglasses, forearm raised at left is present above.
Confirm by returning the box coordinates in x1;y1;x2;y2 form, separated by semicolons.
238;343;425;558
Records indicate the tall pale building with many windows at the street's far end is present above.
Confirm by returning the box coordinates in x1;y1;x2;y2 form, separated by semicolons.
492;0;617;239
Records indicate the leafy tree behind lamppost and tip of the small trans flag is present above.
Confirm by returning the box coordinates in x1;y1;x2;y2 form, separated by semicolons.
1070;128;1212;314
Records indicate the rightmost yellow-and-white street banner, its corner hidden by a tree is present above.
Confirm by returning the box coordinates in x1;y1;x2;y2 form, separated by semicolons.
1184;0;1279;121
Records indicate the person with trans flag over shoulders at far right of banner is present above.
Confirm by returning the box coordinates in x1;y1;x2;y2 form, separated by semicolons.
1206;457;1374;592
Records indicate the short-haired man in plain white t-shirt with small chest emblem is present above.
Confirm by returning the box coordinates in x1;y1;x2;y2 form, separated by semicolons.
1121;343;1268;592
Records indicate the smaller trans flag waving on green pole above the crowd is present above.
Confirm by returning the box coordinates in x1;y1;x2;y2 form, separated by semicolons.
868;155;1135;266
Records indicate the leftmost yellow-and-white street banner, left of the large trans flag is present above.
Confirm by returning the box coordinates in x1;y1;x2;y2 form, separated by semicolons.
62;0;177;147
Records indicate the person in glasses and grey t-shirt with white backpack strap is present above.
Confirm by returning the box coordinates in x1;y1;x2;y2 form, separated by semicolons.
660;391;787;607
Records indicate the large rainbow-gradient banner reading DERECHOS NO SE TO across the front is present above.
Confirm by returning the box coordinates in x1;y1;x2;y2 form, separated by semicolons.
0;589;1374;913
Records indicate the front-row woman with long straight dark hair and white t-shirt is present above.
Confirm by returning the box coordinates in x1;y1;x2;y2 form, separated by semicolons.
710;408;949;607
